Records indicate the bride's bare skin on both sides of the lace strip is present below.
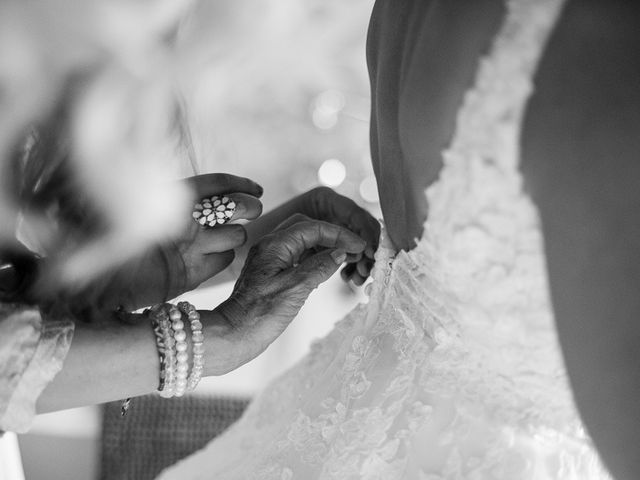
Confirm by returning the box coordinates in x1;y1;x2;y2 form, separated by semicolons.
368;0;640;479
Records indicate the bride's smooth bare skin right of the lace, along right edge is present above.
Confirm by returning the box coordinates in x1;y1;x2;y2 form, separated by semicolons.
523;1;640;480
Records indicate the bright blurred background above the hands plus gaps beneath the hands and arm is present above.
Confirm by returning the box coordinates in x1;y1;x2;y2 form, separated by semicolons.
7;0;381;480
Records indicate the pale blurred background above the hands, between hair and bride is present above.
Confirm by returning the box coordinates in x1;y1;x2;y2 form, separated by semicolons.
177;0;378;216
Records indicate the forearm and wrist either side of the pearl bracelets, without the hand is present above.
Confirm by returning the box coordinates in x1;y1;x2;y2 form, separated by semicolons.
36;311;236;413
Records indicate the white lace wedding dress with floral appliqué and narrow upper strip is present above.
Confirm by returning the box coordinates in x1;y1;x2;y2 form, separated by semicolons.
161;0;609;480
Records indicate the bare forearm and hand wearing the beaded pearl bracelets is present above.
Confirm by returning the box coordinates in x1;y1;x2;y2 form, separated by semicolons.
36;216;366;413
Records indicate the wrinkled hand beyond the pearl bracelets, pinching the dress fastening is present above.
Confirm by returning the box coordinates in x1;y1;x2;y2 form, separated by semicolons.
212;219;366;373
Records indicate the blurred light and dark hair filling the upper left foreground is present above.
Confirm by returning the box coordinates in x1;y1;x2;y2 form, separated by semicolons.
0;0;191;322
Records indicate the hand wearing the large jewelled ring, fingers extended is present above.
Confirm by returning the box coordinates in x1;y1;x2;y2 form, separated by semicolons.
73;173;262;310
